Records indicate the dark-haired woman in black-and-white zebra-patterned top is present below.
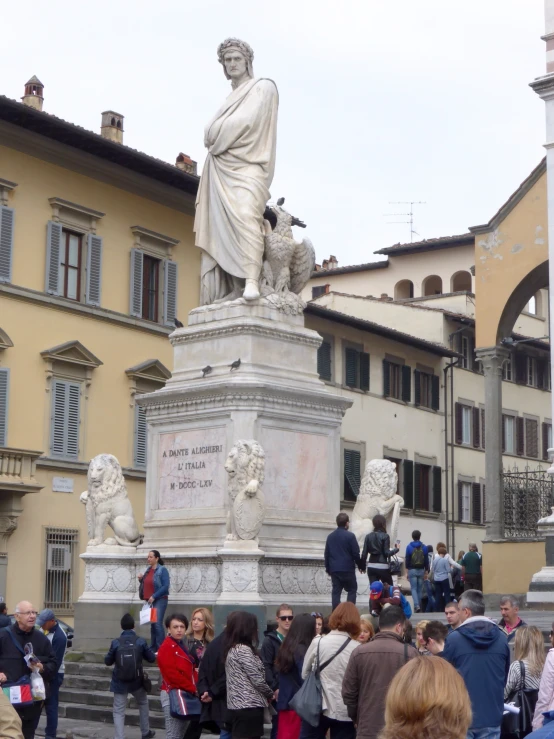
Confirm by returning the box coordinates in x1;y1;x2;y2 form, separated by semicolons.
224;611;274;739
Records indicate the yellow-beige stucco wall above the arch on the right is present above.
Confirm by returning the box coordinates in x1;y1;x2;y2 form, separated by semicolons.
475;174;548;347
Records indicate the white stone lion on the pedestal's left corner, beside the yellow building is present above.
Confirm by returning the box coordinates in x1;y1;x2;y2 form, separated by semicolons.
80;454;142;547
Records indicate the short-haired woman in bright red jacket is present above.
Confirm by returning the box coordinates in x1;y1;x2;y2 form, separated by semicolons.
158;613;198;739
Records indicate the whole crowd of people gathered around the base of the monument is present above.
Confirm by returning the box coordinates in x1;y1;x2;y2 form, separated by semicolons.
0;536;554;739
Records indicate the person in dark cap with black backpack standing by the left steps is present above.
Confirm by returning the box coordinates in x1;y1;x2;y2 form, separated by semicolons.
104;613;156;739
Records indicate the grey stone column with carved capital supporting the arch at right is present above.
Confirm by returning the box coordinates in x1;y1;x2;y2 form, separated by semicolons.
476;346;508;541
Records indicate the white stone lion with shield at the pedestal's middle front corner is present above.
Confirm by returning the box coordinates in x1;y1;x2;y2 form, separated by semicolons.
225;441;265;542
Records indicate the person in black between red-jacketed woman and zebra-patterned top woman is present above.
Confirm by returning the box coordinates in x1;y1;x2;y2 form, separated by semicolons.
197;624;231;739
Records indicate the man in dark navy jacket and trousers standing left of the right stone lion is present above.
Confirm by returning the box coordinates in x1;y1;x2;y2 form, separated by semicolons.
325;513;362;610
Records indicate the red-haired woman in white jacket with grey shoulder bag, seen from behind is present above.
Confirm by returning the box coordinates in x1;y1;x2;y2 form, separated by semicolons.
300;602;360;739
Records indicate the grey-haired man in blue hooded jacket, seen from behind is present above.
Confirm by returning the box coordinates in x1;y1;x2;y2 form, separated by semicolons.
441;590;510;739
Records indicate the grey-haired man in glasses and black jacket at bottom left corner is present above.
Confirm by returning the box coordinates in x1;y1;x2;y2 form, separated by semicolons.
0;600;58;739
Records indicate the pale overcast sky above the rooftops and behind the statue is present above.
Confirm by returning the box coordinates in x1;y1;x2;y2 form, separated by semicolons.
0;0;545;265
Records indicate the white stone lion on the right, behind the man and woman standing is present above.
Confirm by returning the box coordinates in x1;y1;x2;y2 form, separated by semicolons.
350;459;404;546
